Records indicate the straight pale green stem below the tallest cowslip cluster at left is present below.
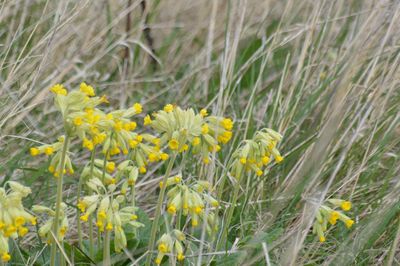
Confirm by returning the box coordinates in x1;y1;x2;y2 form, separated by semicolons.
50;135;69;266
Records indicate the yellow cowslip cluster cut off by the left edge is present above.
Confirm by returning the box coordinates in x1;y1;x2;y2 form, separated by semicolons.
0;181;36;262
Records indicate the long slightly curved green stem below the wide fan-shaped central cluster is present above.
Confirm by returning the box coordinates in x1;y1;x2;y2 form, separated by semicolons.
145;153;176;266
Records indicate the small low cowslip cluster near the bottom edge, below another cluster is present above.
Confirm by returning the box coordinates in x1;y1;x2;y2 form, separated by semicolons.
155;229;185;265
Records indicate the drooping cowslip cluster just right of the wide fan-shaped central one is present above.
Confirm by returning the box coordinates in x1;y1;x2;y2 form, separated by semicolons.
232;128;283;178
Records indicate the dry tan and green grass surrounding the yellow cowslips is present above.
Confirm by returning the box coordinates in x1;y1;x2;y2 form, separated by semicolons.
0;0;400;265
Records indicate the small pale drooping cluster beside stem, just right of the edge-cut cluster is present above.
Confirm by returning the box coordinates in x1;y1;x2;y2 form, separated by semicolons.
32;203;69;243
